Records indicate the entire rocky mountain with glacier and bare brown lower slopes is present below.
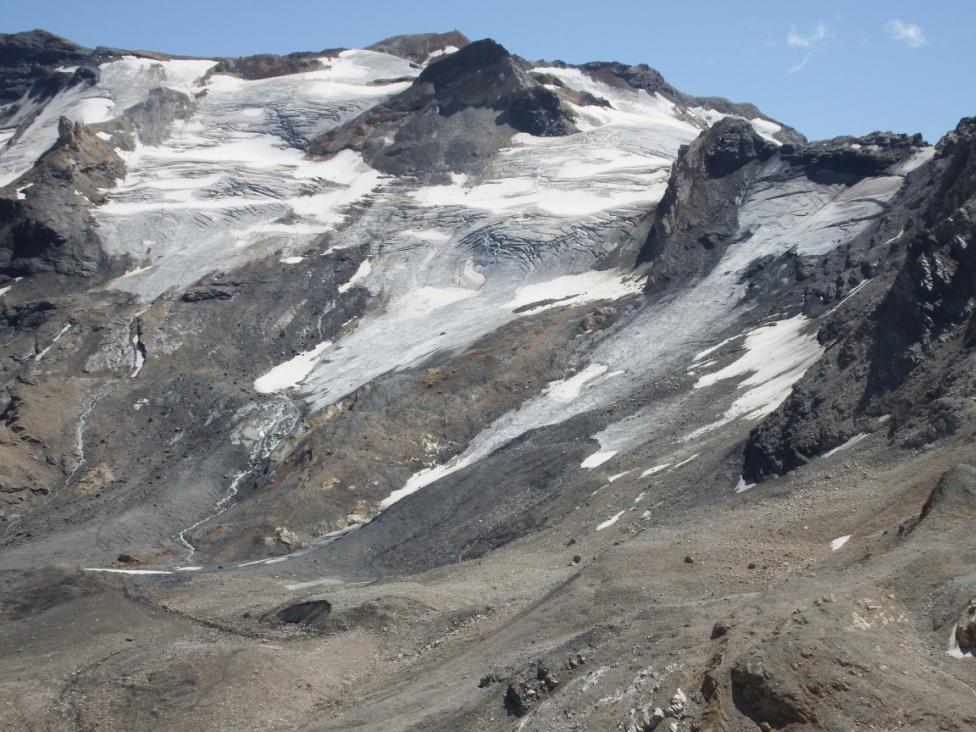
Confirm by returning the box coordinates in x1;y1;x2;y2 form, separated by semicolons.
0;31;976;732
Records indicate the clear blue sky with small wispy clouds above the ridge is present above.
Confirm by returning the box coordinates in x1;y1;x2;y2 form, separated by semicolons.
0;0;976;141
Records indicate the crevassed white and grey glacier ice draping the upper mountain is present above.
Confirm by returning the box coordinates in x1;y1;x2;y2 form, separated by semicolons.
0;30;924;560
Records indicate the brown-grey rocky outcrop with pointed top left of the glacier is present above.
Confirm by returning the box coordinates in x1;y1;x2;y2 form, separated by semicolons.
0;118;125;277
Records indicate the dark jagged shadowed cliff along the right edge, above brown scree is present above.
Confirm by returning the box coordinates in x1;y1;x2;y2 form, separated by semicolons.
744;119;976;480
